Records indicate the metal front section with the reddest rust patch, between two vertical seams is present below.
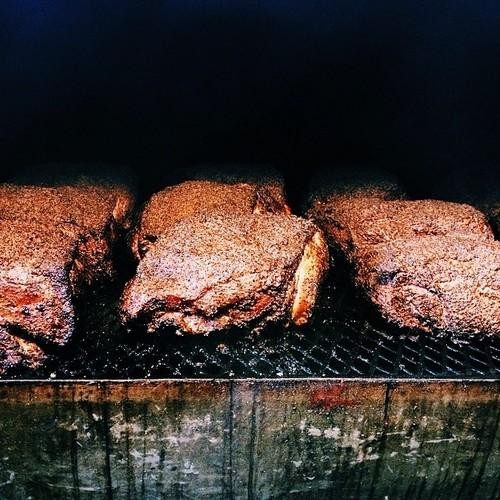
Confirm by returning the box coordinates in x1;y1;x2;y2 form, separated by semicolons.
242;381;385;498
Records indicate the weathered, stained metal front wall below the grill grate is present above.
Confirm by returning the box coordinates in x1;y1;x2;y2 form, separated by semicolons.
0;379;500;499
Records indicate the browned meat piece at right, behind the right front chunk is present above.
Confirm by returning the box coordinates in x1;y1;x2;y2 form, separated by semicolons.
309;197;493;260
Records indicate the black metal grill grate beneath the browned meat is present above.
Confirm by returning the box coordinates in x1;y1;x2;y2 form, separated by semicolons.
27;278;500;378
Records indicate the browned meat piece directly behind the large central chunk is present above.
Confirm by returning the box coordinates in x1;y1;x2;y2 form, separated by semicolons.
132;180;290;259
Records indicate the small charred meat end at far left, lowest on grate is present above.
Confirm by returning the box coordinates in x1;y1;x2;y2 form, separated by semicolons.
0;328;45;376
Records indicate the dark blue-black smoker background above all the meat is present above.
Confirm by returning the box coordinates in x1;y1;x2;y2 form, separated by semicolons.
0;0;500;193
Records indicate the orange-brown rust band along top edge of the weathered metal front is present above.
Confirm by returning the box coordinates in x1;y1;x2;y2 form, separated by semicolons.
0;379;500;411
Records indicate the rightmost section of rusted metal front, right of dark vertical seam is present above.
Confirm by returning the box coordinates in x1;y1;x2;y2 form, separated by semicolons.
377;382;500;498
